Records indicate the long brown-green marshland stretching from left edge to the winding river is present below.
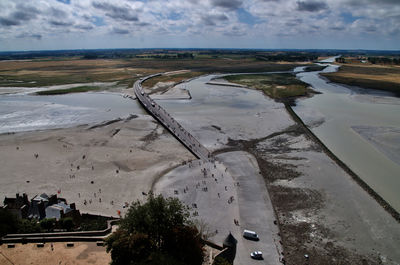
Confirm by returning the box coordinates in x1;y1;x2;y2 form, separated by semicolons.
0;56;306;88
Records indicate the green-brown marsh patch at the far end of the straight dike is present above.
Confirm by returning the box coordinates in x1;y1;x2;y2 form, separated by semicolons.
224;73;309;99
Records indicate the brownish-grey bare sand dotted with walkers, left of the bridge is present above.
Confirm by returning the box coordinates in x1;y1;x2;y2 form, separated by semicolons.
0;115;193;216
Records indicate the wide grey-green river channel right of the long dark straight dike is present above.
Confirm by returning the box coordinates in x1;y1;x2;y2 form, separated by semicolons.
294;61;400;211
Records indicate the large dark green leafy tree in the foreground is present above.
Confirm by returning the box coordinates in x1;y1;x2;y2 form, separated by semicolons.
106;194;204;265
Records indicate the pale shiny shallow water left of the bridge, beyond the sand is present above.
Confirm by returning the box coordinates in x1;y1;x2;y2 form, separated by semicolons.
0;93;144;133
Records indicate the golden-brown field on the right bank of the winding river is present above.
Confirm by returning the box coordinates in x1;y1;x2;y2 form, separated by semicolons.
322;64;400;96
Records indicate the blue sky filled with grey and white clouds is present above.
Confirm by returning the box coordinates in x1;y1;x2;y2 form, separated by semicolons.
0;0;400;51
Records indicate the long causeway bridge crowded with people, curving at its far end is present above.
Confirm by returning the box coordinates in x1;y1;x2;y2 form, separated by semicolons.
133;74;212;162
